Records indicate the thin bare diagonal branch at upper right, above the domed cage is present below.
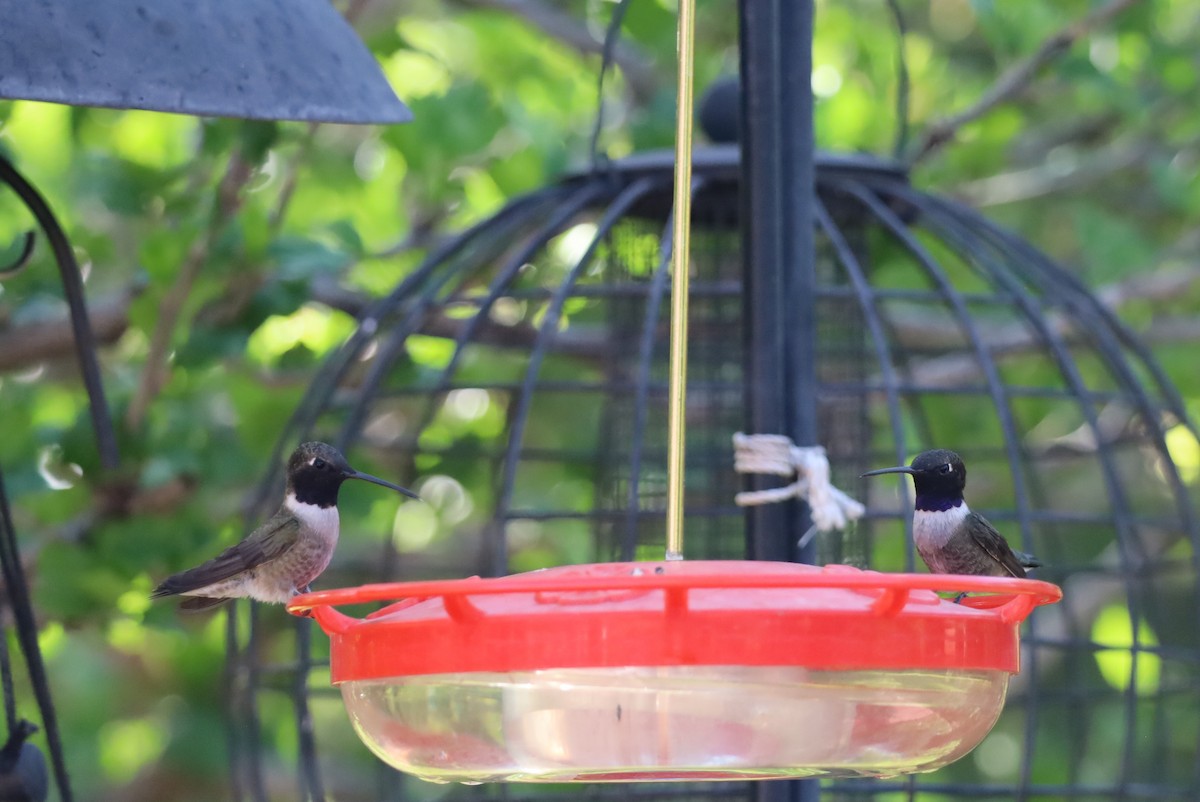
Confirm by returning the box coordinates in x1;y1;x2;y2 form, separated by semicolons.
910;0;1141;164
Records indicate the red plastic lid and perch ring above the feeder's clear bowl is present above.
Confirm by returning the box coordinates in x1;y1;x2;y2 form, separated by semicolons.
288;561;1062;683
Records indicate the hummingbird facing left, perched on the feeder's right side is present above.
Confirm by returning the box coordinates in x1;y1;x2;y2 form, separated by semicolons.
863;449;1042;579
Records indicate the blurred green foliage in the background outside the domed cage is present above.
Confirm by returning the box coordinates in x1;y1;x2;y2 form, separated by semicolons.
0;0;1200;801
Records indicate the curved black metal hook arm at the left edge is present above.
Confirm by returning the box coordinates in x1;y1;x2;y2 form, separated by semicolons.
0;155;120;469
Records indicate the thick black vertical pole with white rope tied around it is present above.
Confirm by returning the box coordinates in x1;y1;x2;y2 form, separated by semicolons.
738;0;821;802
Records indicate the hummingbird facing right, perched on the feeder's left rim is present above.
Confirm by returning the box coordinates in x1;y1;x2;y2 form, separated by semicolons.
150;443;418;612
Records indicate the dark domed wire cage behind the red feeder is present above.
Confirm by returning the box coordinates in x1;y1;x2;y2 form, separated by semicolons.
230;141;1200;800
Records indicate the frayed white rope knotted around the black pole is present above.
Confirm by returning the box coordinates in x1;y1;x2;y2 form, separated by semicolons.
733;432;866;532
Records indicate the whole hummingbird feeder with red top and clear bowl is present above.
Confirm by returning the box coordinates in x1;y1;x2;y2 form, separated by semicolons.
289;561;1062;783
